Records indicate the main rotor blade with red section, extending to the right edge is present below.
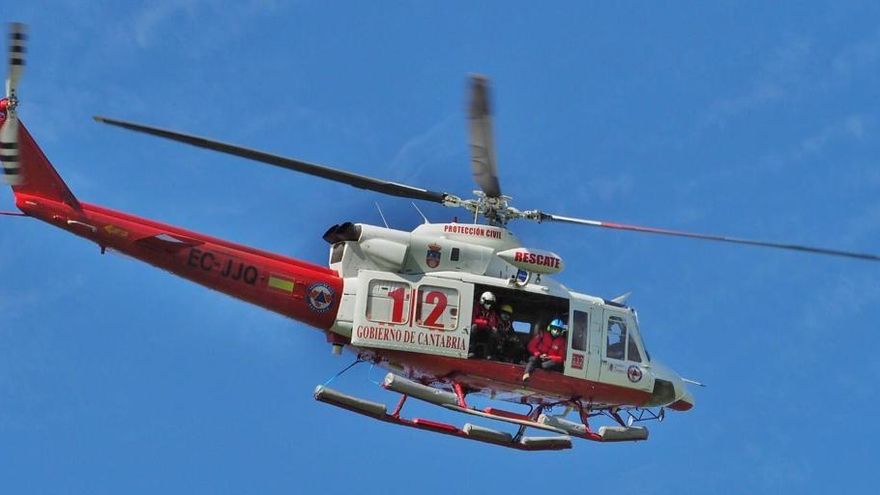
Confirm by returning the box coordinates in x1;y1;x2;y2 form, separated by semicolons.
533;212;880;261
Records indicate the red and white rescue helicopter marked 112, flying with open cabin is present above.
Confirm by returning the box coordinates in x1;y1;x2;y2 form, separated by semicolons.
0;24;880;451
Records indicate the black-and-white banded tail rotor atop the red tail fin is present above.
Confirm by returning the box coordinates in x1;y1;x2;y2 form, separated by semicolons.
0;22;27;185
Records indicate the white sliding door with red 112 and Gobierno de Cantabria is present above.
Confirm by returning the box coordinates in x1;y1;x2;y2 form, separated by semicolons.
351;270;473;358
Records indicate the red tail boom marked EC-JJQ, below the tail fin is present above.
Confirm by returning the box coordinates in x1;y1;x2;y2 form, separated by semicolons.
15;191;342;330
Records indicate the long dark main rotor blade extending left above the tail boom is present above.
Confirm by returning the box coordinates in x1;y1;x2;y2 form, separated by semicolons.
94;117;449;204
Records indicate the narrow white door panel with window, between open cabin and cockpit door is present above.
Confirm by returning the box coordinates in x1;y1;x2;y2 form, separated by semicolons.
565;298;602;381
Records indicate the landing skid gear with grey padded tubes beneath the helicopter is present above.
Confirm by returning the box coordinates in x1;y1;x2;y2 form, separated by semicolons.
315;373;648;451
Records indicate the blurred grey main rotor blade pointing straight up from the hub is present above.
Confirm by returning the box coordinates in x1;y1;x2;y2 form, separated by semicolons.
468;74;501;198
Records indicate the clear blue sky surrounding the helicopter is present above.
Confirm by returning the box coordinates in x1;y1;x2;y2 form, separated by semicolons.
0;0;880;493
